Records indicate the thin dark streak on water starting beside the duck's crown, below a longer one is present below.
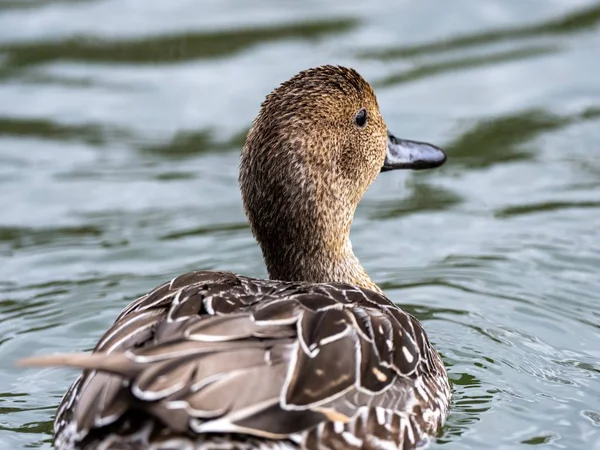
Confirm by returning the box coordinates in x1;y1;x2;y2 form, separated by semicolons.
373;45;559;88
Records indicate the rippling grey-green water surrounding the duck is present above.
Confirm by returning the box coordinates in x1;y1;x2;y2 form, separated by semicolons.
0;0;600;450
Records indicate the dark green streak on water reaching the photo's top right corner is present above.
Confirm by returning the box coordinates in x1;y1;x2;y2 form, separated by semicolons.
360;3;600;59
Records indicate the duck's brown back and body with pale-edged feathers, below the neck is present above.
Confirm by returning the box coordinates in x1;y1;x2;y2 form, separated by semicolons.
55;272;450;449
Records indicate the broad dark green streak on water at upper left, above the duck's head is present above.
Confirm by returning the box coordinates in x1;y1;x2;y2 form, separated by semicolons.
0;19;358;68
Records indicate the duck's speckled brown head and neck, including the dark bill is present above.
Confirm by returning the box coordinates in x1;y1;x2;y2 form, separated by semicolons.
239;66;446;290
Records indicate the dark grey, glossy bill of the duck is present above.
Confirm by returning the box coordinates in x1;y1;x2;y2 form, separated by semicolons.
381;133;446;172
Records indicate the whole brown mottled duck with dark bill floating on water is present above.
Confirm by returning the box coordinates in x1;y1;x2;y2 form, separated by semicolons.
21;65;451;450
